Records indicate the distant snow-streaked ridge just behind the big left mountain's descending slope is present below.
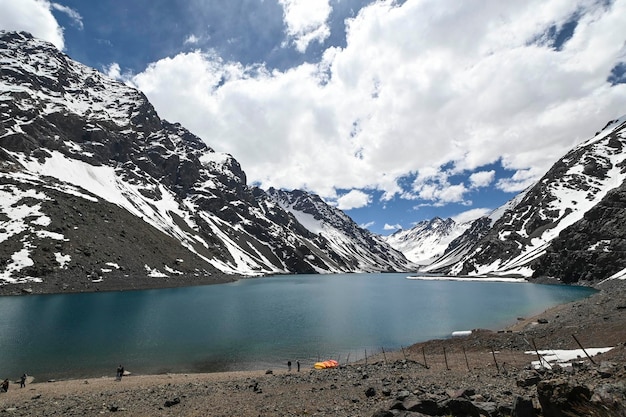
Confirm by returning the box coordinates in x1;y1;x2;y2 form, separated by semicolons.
267;188;416;272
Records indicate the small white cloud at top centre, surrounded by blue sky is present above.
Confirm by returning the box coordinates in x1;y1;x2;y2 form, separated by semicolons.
278;0;332;53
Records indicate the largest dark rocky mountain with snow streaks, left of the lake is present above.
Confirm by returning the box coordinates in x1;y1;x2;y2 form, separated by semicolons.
0;32;410;290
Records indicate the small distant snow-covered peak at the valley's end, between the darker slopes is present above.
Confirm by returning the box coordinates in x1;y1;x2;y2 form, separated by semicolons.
384;217;471;266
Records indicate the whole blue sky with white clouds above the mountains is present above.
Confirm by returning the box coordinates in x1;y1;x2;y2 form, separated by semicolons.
0;0;626;235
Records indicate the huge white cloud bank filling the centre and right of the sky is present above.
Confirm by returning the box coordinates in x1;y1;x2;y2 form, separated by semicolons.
134;0;626;205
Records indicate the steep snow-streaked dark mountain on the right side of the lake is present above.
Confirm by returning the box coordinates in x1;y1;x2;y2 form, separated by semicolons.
424;117;626;282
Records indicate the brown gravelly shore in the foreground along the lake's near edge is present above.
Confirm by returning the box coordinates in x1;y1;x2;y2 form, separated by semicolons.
0;281;626;417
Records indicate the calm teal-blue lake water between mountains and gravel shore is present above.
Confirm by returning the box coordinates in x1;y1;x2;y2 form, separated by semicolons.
0;274;593;380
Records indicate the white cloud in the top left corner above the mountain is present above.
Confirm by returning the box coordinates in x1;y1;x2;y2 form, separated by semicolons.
0;0;65;50
